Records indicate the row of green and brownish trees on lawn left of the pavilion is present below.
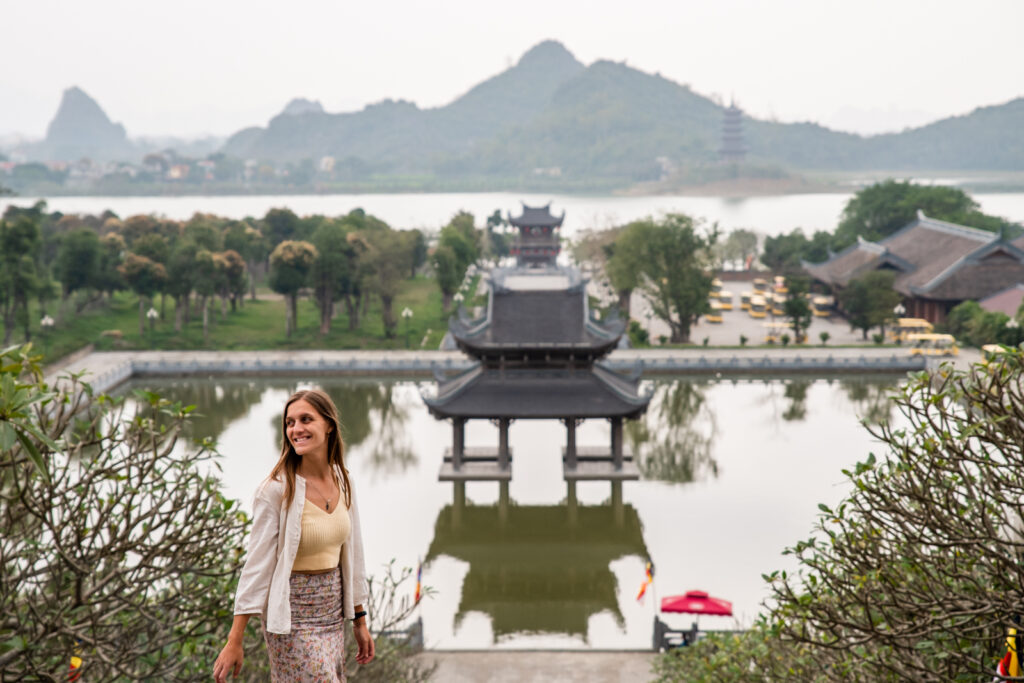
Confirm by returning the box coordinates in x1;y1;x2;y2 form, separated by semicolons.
0;202;497;344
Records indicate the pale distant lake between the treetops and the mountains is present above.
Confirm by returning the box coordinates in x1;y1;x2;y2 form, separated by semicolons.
3;191;1024;237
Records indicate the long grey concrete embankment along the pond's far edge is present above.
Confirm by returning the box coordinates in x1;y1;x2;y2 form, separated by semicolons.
48;346;973;391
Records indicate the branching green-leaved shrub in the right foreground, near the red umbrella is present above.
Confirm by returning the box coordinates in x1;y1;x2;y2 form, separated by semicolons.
656;350;1024;681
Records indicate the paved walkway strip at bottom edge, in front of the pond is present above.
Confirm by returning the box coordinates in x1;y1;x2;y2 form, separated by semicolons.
409;650;657;683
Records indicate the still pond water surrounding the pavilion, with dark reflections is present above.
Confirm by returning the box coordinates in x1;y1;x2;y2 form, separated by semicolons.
126;376;901;649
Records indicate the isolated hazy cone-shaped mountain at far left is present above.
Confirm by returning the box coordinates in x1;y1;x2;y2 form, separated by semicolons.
30;87;134;161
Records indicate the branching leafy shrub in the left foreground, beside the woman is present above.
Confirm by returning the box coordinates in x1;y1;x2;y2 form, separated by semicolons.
0;348;248;681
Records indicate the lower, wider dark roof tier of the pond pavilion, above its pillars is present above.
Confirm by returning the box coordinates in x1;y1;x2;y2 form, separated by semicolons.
423;364;650;420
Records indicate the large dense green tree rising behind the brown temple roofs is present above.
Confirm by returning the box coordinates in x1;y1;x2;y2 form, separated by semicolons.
835;179;1016;249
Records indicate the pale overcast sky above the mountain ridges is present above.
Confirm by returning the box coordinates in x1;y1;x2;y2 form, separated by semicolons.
0;0;1024;137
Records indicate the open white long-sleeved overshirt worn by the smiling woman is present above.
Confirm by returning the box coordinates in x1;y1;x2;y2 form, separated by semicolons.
234;470;370;634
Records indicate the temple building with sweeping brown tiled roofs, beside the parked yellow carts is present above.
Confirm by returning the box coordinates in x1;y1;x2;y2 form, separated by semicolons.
803;211;1024;323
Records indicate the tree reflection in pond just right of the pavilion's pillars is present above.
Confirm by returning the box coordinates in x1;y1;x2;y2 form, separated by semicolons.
626;379;718;483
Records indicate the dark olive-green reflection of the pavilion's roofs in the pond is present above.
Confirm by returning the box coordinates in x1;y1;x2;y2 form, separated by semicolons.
427;493;647;638
